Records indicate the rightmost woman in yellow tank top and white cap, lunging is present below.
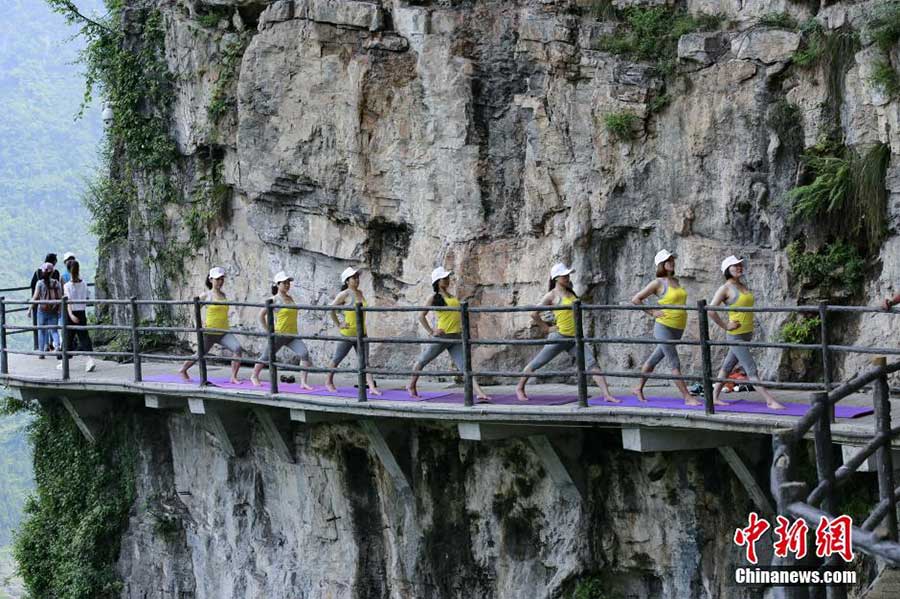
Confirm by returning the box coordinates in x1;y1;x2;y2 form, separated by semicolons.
709;256;784;410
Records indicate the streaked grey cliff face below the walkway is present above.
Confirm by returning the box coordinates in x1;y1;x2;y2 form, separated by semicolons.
112;413;764;599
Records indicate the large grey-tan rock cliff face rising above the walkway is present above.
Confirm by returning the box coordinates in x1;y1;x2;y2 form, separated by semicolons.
96;0;900;382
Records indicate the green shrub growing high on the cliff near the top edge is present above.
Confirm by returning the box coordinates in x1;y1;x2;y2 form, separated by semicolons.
599;6;721;76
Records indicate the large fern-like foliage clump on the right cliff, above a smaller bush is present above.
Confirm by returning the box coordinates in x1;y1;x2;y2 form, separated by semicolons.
787;139;891;253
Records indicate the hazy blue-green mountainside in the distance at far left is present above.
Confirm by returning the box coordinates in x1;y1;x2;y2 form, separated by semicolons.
0;0;102;599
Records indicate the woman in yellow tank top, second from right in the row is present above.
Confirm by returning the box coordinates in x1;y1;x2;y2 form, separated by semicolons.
631;250;701;406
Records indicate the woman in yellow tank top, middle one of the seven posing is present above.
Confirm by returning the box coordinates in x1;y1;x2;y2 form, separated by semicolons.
406;266;491;402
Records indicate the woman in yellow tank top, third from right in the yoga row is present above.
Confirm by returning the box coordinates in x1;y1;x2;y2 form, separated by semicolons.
516;264;620;403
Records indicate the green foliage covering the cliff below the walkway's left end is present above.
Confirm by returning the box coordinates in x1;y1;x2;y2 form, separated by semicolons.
3;398;135;599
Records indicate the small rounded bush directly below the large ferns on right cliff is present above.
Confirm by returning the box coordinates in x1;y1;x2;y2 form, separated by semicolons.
787;241;866;295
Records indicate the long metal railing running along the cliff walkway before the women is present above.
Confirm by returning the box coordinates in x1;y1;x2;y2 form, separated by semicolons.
0;296;900;414
